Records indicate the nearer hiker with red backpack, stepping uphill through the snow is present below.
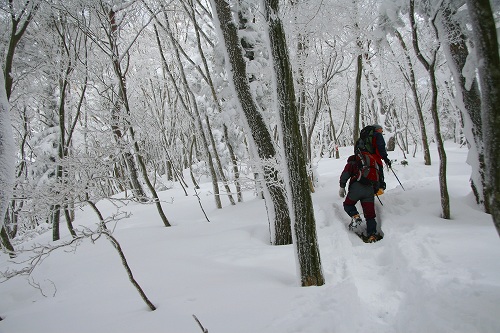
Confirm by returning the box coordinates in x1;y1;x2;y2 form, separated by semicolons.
339;153;380;243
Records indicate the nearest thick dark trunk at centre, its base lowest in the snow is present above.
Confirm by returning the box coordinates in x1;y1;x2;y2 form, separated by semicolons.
265;0;325;286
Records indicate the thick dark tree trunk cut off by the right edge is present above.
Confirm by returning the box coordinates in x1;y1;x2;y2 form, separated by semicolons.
467;0;500;235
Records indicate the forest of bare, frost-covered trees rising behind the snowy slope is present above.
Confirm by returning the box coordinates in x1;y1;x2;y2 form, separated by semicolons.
0;0;500;285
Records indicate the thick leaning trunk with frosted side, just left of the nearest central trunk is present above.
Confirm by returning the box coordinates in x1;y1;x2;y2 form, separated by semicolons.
213;0;292;245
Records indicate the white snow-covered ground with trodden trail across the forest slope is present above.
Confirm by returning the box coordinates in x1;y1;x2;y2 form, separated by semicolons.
0;144;500;333
